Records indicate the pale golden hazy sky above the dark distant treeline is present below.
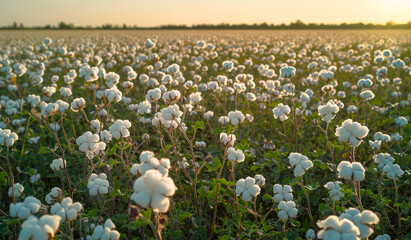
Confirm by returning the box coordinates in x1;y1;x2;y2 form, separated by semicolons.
0;0;411;26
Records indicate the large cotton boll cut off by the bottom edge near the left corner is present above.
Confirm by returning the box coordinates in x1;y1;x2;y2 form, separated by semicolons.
18;215;60;240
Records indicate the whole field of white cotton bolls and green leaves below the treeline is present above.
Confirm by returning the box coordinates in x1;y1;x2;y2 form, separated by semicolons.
0;30;411;240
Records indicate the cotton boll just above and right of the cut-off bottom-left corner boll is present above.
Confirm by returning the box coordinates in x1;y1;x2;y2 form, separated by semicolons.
50;197;83;224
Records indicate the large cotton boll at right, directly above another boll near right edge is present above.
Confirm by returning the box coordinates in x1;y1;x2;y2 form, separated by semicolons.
335;119;368;147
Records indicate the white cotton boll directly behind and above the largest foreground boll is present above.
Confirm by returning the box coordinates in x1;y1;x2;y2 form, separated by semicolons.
130;151;171;176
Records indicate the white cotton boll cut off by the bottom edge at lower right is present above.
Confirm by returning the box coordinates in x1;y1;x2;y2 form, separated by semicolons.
317;215;360;240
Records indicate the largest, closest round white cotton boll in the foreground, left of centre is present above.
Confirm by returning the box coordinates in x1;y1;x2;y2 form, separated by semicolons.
130;169;177;213
